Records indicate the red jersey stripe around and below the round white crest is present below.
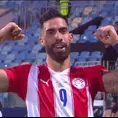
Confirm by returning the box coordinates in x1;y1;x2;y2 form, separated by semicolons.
70;68;88;117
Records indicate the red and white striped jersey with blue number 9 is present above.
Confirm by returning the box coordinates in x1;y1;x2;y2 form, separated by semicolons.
5;64;104;117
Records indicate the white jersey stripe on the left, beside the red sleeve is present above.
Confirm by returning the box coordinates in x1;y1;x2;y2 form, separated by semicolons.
26;65;40;117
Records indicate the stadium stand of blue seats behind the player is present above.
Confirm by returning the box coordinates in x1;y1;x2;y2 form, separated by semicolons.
0;0;118;116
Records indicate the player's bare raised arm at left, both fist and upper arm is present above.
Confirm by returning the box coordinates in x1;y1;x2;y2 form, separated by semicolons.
0;23;24;92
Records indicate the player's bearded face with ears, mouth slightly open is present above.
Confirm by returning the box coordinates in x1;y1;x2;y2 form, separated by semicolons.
41;17;73;62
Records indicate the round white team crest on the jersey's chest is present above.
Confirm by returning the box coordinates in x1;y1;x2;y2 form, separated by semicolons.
72;78;85;89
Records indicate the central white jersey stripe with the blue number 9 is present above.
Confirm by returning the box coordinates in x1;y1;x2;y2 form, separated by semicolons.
49;69;74;117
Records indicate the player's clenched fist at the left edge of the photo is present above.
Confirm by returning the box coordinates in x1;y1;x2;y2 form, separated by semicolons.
0;22;25;42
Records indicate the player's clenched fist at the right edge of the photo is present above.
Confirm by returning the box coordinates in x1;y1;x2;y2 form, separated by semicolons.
94;25;118;46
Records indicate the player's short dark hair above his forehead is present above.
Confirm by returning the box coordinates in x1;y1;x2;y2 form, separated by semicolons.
40;8;68;27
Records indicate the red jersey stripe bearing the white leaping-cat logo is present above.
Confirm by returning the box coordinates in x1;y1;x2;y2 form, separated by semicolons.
38;65;55;117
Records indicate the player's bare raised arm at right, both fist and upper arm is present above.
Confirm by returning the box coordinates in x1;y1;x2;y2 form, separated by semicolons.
95;26;118;93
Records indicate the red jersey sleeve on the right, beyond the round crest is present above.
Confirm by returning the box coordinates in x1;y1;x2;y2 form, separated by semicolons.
84;65;107;99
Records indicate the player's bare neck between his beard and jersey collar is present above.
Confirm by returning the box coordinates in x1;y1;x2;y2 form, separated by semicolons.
47;56;71;72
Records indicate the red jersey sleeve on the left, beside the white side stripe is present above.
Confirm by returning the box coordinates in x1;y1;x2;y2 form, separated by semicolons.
4;64;31;100
